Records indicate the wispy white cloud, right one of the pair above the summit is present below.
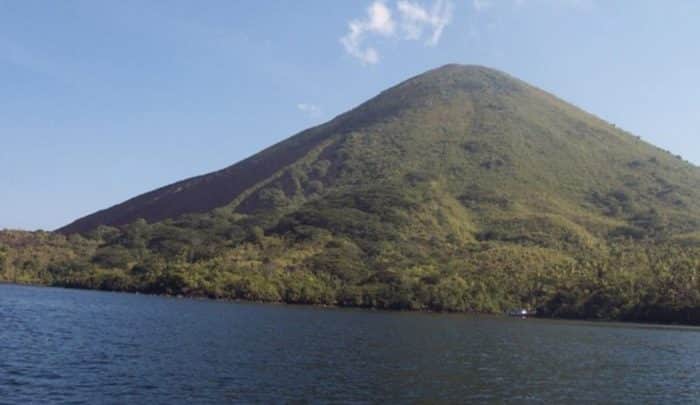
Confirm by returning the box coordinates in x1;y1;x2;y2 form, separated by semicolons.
396;0;452;46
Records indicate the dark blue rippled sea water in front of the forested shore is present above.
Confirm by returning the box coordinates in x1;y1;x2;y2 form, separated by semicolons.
0;285;700;404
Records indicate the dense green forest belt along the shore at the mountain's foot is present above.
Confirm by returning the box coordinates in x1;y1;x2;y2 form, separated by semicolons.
0;182;700;323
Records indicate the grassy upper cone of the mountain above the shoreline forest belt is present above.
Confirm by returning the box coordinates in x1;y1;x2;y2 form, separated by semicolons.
59;65;700;242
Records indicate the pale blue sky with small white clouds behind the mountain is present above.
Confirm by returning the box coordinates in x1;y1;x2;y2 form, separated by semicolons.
0;0;700;229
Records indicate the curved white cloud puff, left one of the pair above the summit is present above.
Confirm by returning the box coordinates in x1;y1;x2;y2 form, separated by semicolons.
340;1;395;64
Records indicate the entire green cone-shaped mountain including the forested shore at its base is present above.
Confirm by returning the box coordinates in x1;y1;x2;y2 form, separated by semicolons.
5;65;700;324
